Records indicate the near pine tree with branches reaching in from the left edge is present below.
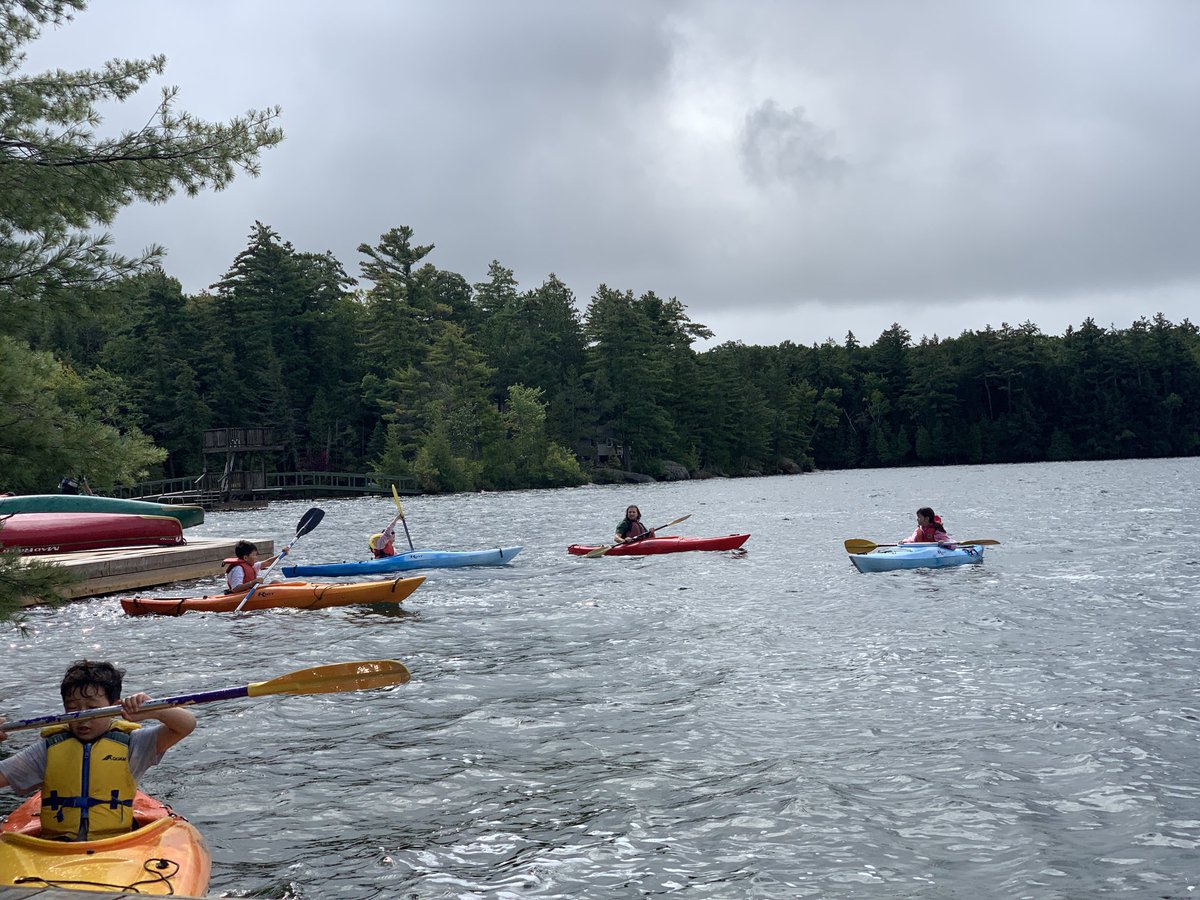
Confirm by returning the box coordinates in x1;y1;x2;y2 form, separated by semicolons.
0;0;283;608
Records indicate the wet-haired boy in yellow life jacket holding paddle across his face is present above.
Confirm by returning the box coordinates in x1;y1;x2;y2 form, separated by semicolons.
0;660;196;841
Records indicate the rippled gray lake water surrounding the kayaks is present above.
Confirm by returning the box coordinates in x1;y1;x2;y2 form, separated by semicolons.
0;458;1200;899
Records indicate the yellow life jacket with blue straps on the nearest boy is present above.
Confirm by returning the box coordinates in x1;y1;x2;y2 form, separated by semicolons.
42;719;142;841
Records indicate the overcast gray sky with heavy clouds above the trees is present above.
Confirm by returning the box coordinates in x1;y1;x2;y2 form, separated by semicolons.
21;0;1200;344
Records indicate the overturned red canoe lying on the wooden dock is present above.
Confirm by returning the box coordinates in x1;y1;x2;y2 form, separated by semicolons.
0;512;185;554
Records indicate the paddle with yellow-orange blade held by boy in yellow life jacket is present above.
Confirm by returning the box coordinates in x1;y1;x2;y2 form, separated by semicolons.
0;659;409;731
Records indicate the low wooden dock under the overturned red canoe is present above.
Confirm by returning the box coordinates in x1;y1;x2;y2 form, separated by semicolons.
19;538;275;609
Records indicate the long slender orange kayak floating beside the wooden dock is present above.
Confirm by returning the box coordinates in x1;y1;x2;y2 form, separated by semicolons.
121;575;425;616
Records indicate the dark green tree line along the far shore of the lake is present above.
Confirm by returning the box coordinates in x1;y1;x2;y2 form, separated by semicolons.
13;223;1200;491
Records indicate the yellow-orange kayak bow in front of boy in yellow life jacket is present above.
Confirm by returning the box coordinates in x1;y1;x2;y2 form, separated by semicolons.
0;791;212;896
